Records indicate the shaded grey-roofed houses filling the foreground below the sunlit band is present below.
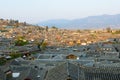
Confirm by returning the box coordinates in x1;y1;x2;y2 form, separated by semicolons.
0;38;120;80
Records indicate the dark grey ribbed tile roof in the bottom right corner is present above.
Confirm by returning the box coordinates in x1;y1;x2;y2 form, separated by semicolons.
83;67;120;80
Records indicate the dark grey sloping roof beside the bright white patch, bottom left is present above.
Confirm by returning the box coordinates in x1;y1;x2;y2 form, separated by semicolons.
9;65;47;80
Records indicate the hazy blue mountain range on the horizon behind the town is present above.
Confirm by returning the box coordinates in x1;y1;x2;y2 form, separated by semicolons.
38;14;120;29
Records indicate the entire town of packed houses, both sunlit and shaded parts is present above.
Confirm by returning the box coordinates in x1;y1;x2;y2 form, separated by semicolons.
0;19;120;80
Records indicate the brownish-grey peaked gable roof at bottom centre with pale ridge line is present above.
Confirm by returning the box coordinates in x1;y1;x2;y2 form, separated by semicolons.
45;62;78;80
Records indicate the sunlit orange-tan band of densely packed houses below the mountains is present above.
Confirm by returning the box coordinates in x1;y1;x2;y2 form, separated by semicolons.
0;25;120;46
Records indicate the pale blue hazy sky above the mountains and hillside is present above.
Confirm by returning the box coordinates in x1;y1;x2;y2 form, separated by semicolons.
0;0;120;23
